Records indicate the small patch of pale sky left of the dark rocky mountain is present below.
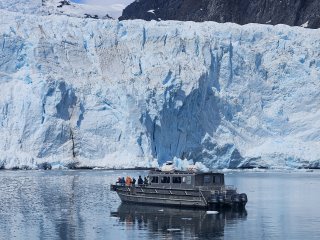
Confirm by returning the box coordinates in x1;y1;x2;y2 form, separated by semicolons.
71;0;134;18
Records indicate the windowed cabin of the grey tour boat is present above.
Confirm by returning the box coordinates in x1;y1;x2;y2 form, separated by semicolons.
149;171;224;188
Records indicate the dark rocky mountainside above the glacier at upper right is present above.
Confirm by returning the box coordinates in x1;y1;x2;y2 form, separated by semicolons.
120;0;320;28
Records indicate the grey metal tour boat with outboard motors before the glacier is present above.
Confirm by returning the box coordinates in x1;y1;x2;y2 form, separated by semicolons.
110;169;248;210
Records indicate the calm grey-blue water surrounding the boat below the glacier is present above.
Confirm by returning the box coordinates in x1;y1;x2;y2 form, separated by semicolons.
0;171;320;240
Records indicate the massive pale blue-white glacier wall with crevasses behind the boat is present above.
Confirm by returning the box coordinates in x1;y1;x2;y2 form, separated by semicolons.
0;8;320;169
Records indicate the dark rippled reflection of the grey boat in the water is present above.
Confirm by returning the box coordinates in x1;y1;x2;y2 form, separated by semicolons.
111;203;247;239
